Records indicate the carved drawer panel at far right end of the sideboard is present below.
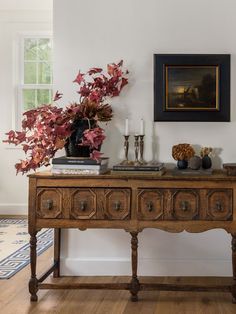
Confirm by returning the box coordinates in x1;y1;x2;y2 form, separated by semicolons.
207;189;233;220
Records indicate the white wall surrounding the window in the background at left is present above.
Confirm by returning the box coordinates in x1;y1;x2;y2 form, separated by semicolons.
0;0;52;215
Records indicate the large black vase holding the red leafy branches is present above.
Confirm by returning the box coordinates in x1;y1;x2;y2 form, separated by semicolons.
65;119;96;157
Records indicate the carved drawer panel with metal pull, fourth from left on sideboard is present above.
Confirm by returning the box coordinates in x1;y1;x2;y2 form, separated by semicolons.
138;189;163;220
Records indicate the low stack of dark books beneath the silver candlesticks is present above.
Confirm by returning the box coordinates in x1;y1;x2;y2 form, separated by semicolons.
111;162;165;176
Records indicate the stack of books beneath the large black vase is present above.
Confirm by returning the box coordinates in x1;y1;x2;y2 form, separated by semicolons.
51;156;109;174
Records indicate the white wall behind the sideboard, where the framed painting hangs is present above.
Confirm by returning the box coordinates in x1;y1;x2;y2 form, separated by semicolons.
54;0;236;275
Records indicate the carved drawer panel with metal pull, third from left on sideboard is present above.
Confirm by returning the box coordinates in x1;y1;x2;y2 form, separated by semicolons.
104;189;131;220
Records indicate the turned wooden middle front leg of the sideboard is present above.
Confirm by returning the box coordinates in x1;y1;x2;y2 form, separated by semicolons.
130;232;140;302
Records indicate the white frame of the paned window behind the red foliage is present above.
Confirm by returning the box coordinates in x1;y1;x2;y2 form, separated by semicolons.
13;32;53;129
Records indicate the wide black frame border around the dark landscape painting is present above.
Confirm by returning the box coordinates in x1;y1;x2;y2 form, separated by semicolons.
154;54;230;122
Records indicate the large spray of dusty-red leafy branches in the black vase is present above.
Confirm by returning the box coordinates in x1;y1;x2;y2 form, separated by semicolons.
4;60;128;174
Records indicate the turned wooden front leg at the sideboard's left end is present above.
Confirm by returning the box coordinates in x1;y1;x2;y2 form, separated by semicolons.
29;232;38;301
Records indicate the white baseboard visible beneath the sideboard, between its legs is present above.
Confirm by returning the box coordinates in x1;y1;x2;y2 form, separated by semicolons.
61;258;232;276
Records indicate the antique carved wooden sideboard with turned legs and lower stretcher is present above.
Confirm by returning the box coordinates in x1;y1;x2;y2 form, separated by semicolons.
29;171;236;302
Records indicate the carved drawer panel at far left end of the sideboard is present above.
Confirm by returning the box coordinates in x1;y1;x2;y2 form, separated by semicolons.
36;188;63;218
